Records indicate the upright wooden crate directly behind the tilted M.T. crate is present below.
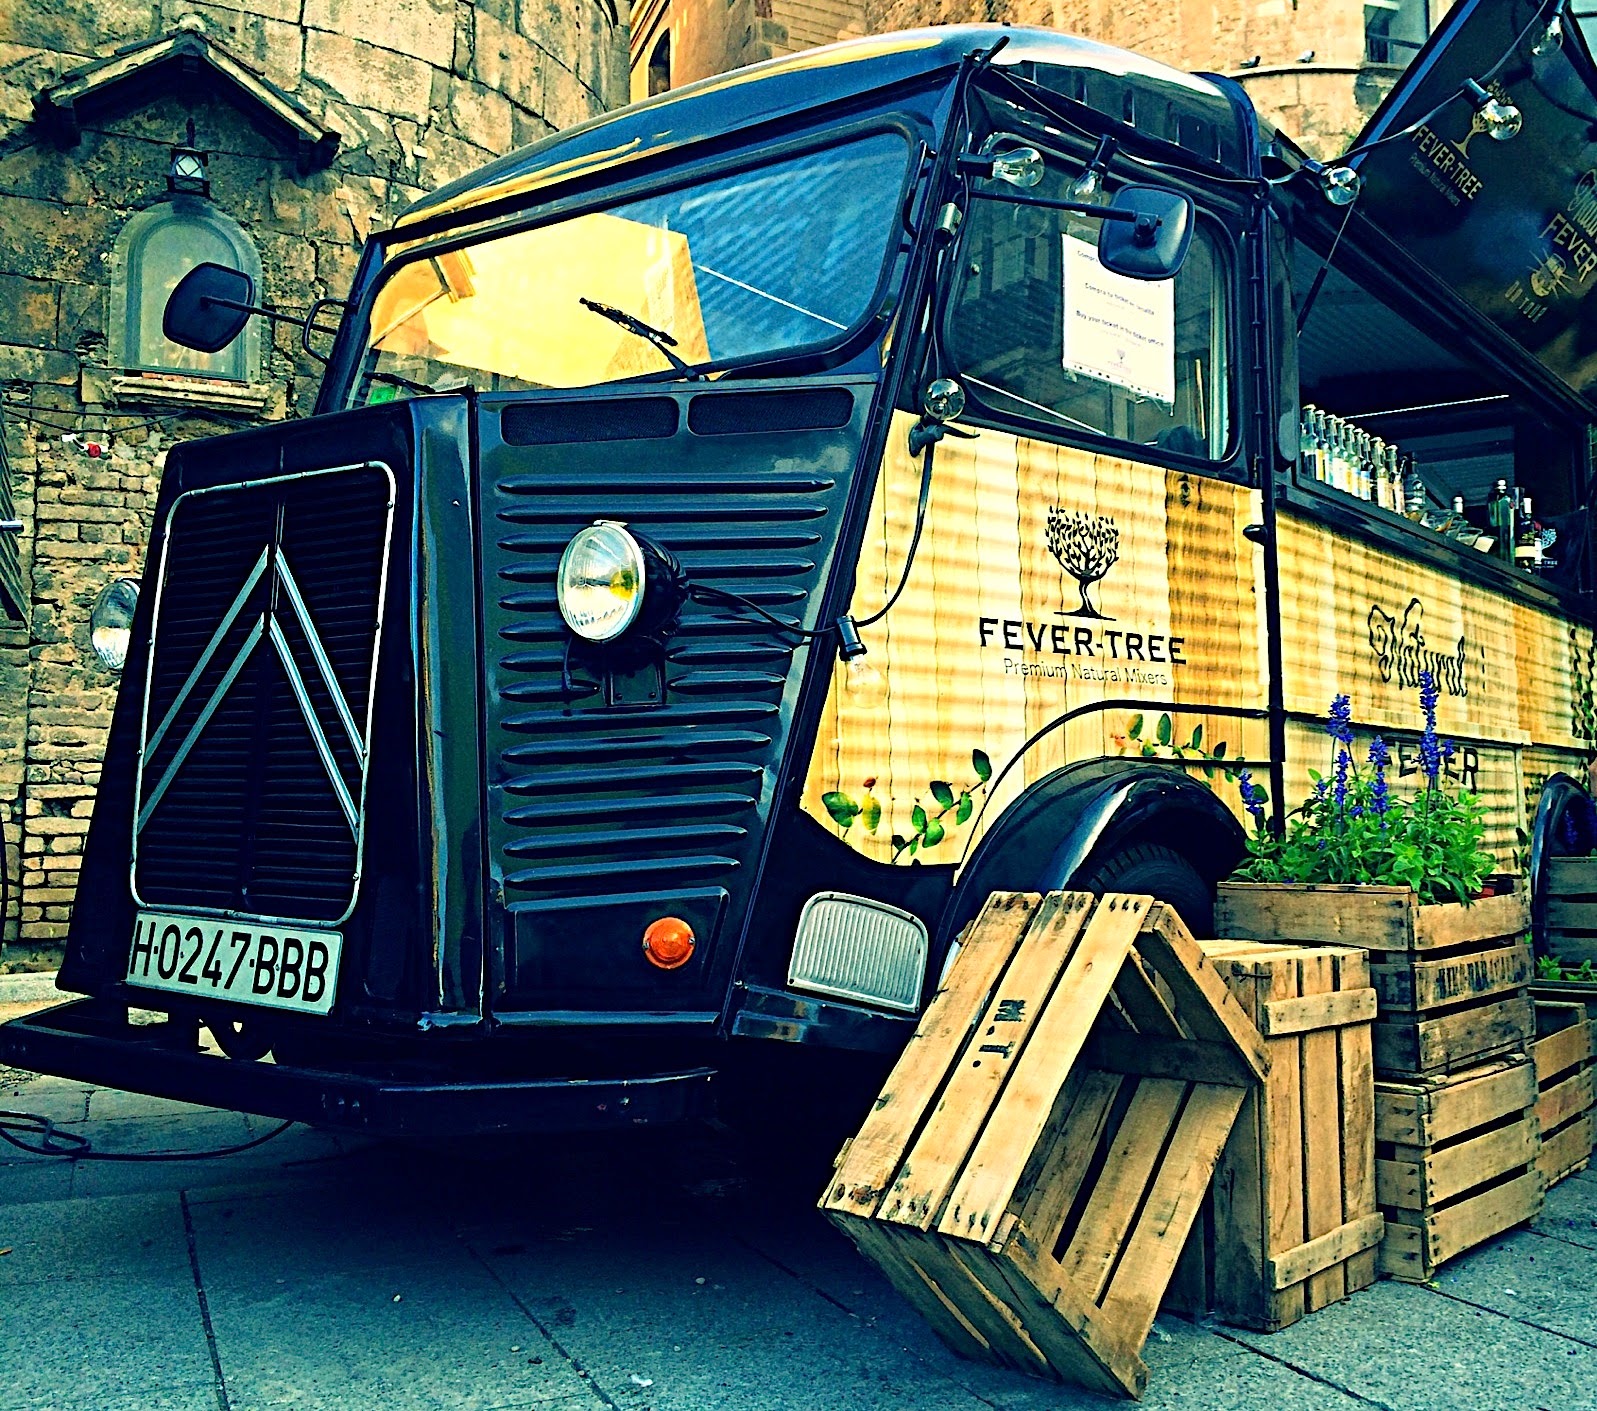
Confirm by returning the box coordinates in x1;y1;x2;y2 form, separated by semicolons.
1182;940;1383;1333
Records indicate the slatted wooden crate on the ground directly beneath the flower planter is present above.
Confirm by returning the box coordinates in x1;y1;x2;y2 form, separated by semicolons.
1375;1053;1546;1282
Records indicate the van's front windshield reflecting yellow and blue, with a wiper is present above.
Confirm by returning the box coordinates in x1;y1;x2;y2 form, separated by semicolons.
351;132;907;404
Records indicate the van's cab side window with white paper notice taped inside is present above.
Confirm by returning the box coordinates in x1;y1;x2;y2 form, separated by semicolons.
944;168;1231;460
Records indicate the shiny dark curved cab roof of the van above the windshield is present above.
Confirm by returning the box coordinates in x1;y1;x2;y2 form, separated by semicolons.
398;24;1258;228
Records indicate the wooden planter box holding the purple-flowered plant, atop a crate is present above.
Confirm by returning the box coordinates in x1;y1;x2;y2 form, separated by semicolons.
1215;883;1535;1076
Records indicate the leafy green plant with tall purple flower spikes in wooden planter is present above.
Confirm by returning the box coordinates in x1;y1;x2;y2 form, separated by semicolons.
1236;672;1495;903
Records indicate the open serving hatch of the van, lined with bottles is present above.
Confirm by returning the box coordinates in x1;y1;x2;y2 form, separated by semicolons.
1294;244;1589;587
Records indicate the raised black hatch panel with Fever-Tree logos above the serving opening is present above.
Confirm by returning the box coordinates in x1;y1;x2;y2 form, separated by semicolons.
1354;0;1597;401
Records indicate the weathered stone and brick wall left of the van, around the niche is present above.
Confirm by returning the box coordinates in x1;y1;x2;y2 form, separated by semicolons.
0;0;628;942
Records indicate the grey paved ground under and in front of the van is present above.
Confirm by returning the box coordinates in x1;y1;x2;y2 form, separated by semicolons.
0;1073;1597;1411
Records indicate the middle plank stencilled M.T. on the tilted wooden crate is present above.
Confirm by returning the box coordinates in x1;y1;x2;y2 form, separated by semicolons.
878;892;1107;1239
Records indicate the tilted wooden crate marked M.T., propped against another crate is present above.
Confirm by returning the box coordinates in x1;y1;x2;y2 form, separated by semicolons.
821;892;1266;1397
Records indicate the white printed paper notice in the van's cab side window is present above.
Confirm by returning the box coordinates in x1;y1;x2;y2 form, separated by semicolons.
1064;235;1175;405
